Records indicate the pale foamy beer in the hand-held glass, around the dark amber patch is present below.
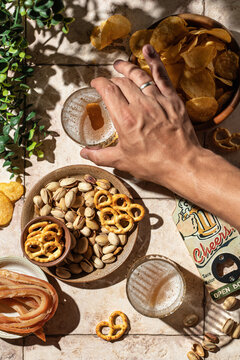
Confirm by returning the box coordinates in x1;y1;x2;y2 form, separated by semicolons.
62;88;115;146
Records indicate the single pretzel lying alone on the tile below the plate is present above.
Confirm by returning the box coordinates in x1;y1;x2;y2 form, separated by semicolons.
96;311;128;341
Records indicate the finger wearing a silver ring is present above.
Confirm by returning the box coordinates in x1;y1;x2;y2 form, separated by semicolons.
114;60;159;97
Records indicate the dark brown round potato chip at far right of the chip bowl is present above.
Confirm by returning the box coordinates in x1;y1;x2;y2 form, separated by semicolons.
214;50;239;80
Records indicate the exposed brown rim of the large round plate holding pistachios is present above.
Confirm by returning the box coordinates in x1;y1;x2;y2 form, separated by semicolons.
21;165;138;284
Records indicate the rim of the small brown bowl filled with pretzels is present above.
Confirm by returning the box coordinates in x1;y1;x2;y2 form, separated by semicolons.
21;216;71;267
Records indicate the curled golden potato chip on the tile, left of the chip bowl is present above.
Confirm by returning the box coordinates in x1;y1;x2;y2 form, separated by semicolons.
90;14;131;50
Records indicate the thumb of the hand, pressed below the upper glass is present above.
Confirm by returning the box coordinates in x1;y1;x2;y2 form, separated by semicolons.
80;146;121;167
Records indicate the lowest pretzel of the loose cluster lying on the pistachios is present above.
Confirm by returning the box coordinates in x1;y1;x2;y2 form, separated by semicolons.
100;207;134;234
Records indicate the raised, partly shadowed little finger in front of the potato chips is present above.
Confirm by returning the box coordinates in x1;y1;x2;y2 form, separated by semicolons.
143;45;175;96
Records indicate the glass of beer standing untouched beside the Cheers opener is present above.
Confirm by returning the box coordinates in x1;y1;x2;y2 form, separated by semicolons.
126;255;186;318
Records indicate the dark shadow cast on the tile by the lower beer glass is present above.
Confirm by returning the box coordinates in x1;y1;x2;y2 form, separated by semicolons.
161;265;204;338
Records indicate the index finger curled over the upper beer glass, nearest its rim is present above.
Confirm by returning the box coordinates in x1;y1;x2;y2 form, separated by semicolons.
91;77;128;133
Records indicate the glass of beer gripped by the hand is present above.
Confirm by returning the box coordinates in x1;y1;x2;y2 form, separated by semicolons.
61;87;117;148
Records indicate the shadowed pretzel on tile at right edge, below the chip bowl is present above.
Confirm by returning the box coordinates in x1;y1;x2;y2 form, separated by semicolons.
213;128;240;152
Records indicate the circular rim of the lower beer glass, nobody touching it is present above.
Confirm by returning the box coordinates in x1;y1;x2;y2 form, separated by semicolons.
126;254;186;319
